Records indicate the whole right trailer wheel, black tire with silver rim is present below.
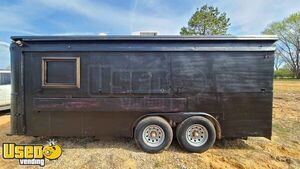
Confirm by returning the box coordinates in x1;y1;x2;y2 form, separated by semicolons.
176;116;216;153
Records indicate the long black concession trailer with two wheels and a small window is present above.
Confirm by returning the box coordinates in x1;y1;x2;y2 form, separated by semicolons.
11;36;277;152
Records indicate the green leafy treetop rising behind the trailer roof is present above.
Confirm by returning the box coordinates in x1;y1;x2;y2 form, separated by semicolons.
180;5;230;35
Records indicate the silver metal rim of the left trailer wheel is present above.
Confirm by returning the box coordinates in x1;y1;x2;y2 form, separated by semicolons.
143;125;165;147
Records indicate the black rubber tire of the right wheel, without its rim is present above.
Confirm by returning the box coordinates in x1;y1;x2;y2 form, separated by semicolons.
176;116;216;153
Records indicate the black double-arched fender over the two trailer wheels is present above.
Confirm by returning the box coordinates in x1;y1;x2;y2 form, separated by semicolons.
131;112;222;139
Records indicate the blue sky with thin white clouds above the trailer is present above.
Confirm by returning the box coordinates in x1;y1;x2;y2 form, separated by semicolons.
0;0;300;69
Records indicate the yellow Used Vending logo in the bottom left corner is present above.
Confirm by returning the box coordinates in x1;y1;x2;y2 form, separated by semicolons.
2;140;62;167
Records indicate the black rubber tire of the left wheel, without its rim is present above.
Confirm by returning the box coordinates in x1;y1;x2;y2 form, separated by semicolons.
134;116;173;153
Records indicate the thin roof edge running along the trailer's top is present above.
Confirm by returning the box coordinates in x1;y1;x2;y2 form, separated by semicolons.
11;35;278;41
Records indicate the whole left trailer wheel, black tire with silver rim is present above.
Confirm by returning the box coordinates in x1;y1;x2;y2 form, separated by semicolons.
134;116;173;153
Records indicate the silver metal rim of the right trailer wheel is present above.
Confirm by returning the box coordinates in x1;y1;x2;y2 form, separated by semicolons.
186;124;208;147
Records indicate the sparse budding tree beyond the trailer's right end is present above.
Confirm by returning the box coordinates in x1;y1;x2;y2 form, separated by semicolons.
263;12;300;79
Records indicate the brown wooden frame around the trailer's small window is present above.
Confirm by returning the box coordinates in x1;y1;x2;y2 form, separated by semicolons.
42;57;80;88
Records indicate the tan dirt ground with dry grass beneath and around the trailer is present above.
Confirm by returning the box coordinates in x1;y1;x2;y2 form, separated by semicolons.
0;80;300;169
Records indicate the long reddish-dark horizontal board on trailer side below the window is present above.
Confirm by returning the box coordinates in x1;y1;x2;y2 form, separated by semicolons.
33;97;186;113
